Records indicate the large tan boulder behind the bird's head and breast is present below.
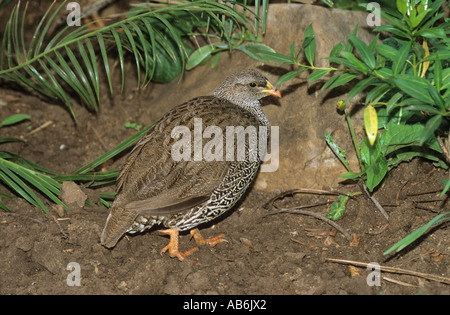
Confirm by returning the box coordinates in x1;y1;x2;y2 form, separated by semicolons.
139;4;374;192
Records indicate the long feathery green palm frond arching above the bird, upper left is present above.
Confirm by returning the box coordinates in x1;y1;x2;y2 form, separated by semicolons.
0;0;260;117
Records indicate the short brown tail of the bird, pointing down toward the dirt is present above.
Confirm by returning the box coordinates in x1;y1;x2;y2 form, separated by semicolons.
100;205;137;248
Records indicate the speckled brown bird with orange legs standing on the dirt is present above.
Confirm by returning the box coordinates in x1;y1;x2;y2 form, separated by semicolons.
101;70;281;260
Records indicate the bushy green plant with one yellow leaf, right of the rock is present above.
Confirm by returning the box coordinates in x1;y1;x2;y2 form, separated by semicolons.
243;0;450;249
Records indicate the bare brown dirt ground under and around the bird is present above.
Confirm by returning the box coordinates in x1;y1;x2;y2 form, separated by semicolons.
0;0;450;294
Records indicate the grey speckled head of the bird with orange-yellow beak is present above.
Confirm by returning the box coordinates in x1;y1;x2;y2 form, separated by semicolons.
213;70;281;107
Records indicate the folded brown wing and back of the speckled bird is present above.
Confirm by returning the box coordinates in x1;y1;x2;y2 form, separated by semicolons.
116;97;257;215
